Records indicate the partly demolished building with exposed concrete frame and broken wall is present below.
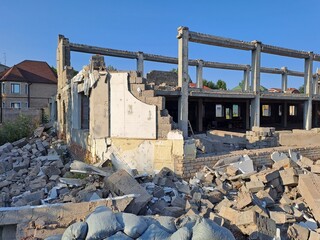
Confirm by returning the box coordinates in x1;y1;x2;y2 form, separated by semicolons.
52;27;320;175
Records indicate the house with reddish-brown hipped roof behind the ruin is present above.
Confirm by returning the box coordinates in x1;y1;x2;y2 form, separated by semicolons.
0;60;57;109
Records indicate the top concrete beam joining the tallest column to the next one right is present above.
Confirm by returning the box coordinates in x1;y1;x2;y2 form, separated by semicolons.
189;31;255;50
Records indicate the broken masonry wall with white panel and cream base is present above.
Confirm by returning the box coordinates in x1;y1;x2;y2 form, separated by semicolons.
57;44;196;172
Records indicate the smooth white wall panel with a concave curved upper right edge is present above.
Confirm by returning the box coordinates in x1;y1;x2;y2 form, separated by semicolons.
110;73;156;139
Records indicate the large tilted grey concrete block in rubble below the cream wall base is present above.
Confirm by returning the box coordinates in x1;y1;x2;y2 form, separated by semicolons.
105;170;152;214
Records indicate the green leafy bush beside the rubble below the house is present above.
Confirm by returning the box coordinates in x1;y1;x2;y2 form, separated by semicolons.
0;115;37;145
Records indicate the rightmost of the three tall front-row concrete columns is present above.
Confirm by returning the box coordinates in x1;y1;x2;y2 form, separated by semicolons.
303;52;313;130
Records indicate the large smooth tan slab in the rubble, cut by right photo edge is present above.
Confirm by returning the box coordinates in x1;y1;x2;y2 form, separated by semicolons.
298;173;320;221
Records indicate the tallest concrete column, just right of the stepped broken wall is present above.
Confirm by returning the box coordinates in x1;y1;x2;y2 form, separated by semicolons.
178;27;189;138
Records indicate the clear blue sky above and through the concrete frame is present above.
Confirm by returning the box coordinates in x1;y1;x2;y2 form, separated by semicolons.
0;0;320;88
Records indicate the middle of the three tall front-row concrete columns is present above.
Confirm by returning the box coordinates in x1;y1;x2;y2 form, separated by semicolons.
250;41;261;127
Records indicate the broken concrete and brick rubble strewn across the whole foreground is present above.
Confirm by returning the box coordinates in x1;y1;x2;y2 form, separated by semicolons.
0;128;320;239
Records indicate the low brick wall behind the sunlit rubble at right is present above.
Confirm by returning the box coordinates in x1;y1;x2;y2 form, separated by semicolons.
175;146;320;179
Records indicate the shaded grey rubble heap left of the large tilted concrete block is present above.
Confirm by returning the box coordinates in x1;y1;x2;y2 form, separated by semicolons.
0;127;112;207
